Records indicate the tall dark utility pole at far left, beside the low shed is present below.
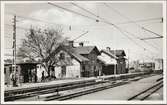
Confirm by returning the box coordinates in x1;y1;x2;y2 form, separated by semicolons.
12;15;16;85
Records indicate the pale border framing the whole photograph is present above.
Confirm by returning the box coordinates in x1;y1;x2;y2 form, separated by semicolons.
1;0;167;104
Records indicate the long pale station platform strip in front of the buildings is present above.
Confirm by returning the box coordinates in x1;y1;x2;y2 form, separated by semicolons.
5;73;154;91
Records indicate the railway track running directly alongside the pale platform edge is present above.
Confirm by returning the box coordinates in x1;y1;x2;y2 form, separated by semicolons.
5;72;154;101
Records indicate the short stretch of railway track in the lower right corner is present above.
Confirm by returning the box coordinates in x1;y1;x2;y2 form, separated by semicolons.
128;78;163;101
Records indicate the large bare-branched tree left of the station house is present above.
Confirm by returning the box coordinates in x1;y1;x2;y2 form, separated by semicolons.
18;27;67;75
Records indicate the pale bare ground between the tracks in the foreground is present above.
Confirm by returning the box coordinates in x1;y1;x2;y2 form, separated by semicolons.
13;75;163;101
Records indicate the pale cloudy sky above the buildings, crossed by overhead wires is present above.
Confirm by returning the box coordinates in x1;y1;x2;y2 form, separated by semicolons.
4;1;163;61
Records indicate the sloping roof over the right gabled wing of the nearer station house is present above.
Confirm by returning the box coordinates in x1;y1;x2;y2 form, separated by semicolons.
74;46;100;55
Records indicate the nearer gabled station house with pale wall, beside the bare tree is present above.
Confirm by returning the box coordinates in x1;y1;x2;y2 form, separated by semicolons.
52;41;101;78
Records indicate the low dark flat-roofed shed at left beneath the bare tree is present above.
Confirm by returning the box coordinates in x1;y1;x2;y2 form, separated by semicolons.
4;62;38;85
